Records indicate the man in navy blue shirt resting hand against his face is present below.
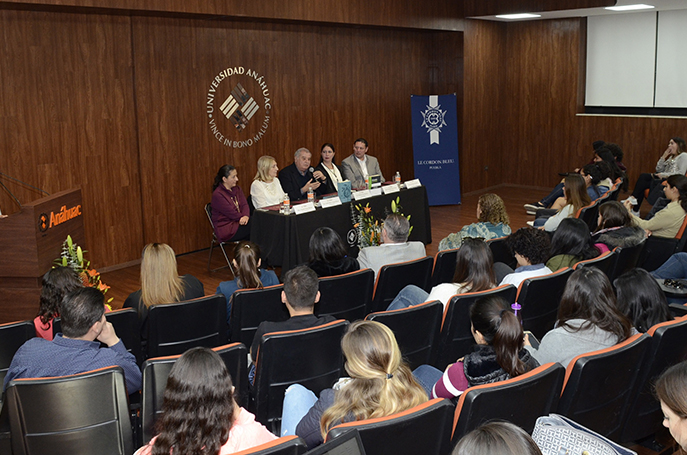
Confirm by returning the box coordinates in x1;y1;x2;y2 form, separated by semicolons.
4;288;141;394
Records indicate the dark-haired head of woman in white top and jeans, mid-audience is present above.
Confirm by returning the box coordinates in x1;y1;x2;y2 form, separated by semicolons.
453;237;496;292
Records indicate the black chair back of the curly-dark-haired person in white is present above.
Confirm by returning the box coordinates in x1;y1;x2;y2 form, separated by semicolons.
516;267;573;340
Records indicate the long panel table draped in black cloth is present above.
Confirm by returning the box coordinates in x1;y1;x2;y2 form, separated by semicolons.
250;186;432;273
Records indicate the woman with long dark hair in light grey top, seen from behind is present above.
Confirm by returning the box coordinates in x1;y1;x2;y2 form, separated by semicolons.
525;267;632;366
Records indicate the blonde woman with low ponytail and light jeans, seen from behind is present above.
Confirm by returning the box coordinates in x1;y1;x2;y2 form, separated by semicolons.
282;321;428;448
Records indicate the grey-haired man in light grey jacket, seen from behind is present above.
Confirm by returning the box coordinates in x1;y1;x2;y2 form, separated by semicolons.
358;213;427;276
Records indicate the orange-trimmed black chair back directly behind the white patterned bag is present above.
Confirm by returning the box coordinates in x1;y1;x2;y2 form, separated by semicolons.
557;333;651;440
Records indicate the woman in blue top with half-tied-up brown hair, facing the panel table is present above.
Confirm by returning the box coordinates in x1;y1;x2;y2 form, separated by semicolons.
217;242;279;324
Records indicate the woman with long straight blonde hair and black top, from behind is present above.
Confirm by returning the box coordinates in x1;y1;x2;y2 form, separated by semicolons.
124;243;205;336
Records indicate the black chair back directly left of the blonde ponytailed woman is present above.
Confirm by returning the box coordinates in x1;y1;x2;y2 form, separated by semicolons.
253;320;349;434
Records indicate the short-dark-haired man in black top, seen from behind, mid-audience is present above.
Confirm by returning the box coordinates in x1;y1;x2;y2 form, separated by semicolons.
250;265;336;366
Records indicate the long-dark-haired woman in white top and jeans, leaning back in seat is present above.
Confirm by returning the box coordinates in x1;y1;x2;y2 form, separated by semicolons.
387;237;496;310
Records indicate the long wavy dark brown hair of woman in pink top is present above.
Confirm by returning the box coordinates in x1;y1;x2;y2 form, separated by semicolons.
152;348;237;455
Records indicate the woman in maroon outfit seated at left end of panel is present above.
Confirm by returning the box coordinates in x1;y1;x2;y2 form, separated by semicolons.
210;164;250;242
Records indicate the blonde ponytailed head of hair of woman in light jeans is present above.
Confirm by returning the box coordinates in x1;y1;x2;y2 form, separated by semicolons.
320;321;427;436
